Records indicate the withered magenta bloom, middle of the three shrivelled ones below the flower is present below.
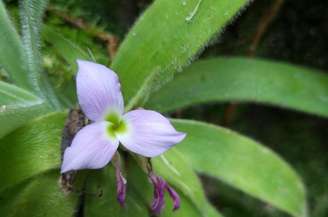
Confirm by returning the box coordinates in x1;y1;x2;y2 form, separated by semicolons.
150;174;167;215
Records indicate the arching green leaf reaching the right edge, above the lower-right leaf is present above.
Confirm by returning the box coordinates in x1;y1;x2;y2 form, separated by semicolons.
147;58;328;117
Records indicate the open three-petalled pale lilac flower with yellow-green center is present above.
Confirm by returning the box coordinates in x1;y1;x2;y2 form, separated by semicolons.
61;60;185;174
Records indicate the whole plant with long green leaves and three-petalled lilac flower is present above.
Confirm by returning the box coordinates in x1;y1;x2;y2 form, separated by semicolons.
0;0;328;217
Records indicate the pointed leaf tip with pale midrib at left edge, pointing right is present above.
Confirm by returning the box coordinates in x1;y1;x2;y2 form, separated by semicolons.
0;81;49;138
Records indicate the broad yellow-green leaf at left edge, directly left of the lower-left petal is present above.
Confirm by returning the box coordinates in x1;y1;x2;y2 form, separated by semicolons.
0;113;66;192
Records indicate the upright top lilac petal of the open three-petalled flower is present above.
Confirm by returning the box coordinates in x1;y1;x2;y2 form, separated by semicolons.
76;60;124;121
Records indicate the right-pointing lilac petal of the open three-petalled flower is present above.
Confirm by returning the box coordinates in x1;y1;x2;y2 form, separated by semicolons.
117;109;186;157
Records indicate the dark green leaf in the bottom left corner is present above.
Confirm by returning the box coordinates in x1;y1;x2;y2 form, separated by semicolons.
0;170;77;217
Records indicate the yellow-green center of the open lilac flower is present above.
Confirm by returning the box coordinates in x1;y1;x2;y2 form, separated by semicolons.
105;113;127;137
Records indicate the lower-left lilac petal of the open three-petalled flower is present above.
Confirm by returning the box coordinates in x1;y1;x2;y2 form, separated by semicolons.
61;122;119;173
